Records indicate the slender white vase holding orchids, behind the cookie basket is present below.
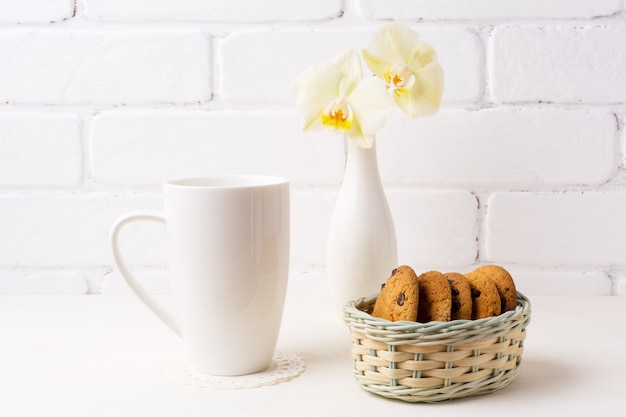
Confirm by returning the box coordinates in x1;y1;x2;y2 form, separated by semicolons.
327;139;398;315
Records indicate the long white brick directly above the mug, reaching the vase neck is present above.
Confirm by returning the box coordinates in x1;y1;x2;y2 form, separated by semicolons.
91;110;344;186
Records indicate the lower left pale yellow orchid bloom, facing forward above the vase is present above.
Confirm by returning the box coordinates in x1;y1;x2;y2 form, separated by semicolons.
291;51;393;148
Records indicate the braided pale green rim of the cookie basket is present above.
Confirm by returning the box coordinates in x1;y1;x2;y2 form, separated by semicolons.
344;291;531;334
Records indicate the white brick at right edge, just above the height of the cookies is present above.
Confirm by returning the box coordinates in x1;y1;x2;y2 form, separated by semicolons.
484;191;626;267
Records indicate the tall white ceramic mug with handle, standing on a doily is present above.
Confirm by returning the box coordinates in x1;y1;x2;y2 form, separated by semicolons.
111;176;289;375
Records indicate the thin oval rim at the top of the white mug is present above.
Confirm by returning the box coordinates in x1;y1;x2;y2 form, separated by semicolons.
164;174;289;189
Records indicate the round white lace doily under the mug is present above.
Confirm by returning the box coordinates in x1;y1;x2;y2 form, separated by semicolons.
173;352;304;389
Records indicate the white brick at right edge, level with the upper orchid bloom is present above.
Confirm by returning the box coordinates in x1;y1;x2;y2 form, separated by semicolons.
490;22;626;104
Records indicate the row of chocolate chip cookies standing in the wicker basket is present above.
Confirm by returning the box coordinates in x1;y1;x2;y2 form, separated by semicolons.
372;265;517;323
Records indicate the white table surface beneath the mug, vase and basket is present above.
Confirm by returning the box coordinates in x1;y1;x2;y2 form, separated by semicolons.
0;276;626;417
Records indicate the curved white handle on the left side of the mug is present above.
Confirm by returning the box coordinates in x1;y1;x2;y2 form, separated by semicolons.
111;213;182;337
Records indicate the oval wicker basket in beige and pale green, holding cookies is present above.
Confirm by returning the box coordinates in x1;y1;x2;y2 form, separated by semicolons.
344;292;530;402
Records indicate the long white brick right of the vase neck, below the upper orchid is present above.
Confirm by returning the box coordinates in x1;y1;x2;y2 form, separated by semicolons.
378;107;619;190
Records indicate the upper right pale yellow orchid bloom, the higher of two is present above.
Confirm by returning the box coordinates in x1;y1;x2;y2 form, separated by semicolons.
362;23;444;117
